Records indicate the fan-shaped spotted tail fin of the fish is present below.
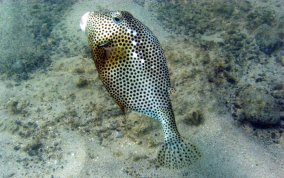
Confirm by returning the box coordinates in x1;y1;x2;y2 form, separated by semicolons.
158;137;201;169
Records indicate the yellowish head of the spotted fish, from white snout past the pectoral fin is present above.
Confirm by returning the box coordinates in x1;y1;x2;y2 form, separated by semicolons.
80;11;149;75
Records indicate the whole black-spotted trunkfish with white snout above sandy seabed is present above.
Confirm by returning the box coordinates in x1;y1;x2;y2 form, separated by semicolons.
80;10;201;169
